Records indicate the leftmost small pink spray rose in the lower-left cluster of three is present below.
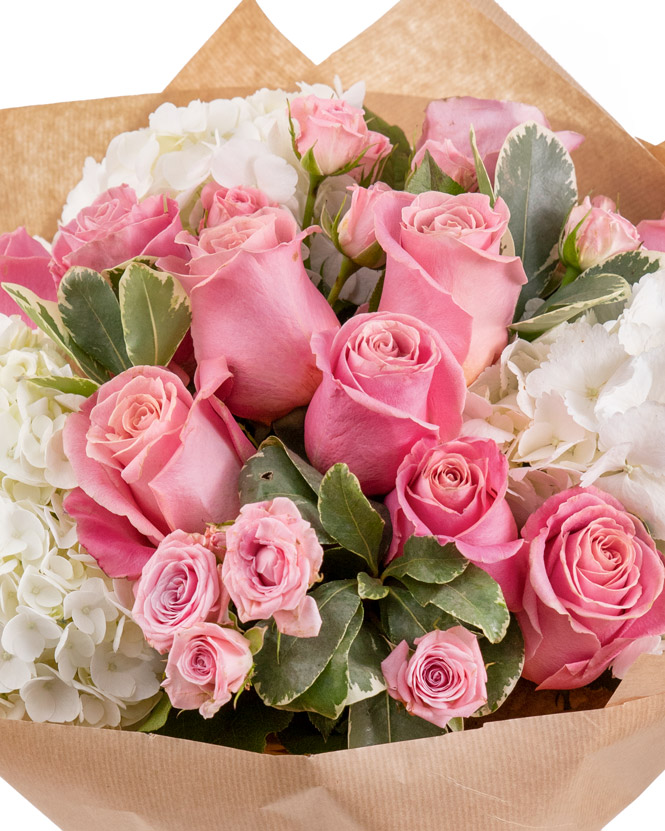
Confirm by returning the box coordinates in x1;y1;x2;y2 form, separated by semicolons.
132;531;222;654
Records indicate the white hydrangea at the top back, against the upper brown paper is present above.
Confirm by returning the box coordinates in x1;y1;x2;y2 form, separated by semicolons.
62;78;365;223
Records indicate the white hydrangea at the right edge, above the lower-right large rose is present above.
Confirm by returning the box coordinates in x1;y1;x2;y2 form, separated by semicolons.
463;271;665;540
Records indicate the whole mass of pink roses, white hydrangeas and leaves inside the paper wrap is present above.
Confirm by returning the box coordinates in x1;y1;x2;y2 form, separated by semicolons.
0;1;665;827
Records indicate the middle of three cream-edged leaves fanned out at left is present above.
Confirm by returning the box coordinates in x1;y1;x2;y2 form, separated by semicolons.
58;266;132;375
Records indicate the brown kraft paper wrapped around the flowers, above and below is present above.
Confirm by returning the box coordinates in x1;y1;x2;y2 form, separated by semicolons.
0;0;665;831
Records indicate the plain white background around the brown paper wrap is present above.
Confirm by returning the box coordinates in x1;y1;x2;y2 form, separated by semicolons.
0;0;665;831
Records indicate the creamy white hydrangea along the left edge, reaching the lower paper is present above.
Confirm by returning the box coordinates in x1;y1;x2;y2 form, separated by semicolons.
0;315;163;727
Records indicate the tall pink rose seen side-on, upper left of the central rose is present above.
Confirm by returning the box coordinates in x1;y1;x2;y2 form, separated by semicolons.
165;208;339;423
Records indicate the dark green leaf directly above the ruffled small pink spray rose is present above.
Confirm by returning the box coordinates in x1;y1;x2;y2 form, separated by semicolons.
238;436;333;545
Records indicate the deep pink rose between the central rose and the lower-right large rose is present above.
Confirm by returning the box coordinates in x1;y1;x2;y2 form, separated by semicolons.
386;438;522;573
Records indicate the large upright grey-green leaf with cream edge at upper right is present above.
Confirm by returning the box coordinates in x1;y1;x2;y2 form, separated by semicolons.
494;122;577;318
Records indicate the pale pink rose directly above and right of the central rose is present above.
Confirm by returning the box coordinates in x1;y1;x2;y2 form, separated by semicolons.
375;192;526;383
